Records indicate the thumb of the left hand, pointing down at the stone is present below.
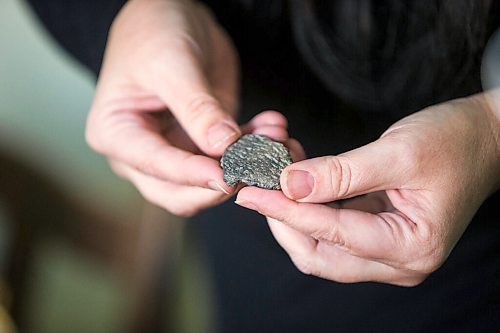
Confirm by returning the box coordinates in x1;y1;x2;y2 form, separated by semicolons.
146;45;241;156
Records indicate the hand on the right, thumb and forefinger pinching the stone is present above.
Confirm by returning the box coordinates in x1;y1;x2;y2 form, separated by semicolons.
236;95;500;286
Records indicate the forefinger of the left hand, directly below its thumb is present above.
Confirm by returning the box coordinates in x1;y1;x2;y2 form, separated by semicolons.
87;113;233;193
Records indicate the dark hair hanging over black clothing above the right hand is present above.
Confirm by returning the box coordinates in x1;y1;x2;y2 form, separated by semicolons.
290;0;491;112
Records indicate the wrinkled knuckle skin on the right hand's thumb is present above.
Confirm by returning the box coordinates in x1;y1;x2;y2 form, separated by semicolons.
326;156;352;198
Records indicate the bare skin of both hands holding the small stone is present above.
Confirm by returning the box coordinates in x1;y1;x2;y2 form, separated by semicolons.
86;0;500;286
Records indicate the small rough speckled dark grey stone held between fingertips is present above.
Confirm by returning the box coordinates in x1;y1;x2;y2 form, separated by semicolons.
220;134;292;190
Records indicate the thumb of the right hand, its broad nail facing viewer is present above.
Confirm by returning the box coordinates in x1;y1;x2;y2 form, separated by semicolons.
280;138;415;203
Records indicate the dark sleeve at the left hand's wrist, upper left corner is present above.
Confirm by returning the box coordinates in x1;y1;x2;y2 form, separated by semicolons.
27;0;126;76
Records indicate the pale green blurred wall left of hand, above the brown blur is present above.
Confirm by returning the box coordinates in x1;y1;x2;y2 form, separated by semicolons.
0;0;142;217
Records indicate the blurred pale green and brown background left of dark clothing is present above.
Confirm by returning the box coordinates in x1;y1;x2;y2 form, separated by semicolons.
0;0;213;333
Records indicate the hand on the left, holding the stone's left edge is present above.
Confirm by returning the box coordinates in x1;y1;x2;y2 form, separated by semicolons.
86;0;242;216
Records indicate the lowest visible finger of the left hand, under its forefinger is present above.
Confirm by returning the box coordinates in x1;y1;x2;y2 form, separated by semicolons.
113;162;230;217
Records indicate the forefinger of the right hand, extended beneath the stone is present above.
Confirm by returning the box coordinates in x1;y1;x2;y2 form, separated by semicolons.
236;187;414;261
